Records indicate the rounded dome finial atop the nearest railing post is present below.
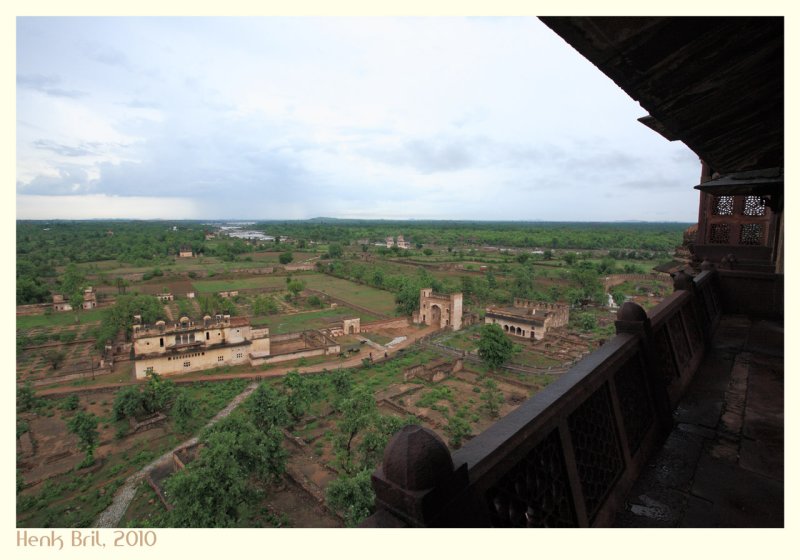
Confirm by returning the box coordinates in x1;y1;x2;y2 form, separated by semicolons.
383;426;453;490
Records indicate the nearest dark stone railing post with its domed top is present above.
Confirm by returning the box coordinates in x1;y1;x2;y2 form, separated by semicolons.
362;426;468;527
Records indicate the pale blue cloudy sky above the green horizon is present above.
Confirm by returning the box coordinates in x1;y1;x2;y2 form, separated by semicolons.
16;17;700;222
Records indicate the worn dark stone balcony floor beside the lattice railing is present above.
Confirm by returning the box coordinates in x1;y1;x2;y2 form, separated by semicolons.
614;316;784;527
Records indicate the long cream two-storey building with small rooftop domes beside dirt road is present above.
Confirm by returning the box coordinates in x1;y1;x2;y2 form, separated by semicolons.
133;315;270;379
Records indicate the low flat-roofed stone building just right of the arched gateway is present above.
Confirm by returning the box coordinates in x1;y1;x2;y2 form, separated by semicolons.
484;298;569;340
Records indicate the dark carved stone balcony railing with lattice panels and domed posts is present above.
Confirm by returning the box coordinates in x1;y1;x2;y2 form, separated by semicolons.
362;267;722;527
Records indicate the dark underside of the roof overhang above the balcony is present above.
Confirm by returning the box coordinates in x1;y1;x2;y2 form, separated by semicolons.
541;17;784;175
